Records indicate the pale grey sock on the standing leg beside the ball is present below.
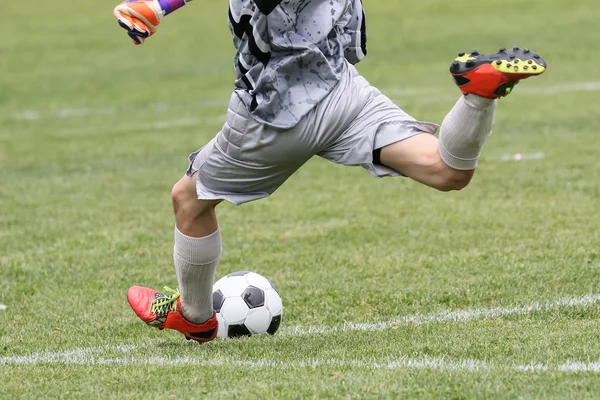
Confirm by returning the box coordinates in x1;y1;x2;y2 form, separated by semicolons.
173;227;222;324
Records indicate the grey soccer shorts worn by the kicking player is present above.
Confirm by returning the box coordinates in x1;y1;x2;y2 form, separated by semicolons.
187;64;438;205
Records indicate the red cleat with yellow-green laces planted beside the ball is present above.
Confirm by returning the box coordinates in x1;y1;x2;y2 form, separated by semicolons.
127;286;219;342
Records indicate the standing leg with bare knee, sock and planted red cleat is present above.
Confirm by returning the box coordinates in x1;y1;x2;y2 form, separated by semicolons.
127;175;221;342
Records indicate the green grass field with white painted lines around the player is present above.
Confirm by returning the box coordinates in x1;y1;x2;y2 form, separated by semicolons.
0;0;600;399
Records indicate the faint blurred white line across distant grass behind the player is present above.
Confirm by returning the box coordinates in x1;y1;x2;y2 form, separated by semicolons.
9;81;600;121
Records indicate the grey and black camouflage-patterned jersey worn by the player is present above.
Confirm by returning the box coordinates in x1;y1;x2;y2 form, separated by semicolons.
229;0;366;128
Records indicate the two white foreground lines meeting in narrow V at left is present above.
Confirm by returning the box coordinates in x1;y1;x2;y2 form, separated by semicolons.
0;295;600;372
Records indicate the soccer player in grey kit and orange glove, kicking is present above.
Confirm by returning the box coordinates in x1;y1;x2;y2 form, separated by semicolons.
114;0;546;342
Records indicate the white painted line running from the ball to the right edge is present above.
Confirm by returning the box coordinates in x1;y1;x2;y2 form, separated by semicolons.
280;294;600;336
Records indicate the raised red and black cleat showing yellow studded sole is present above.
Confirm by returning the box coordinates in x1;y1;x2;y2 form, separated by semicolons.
450;47;546;99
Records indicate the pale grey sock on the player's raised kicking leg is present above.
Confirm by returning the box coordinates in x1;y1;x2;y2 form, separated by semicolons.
439;94;496;170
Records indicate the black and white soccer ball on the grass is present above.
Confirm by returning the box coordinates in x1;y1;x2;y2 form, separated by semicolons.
213;271;283;338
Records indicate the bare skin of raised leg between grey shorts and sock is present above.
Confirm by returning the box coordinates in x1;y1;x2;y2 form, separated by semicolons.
381;133;474;191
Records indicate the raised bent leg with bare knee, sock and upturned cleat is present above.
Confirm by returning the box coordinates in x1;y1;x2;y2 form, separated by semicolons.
380;47;546;191
